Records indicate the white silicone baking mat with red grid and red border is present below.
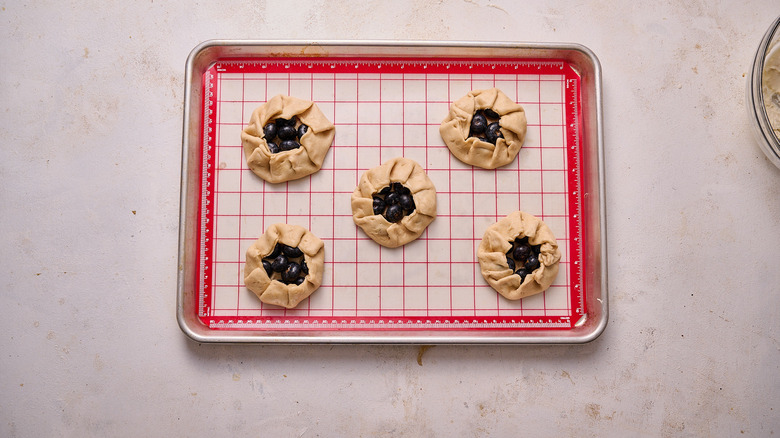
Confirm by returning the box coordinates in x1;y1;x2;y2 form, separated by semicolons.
198;57;586;330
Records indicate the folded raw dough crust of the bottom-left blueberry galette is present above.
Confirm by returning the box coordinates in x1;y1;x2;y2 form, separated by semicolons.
244;224;325;309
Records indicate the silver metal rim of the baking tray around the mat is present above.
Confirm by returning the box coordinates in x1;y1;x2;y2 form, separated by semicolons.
176;40;608;344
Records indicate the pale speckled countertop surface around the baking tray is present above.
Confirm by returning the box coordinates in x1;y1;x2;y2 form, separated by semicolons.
0;0;780;437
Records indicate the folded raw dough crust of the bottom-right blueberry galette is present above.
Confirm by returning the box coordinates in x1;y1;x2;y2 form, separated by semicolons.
477;211;561;300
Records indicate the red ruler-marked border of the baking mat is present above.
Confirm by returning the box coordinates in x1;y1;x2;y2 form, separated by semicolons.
197;58;587;330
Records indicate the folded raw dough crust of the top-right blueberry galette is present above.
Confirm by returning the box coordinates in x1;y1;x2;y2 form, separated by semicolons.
439;88;527;169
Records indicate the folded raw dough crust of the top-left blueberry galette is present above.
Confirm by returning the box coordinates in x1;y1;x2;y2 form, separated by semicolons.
241;94;336;183
